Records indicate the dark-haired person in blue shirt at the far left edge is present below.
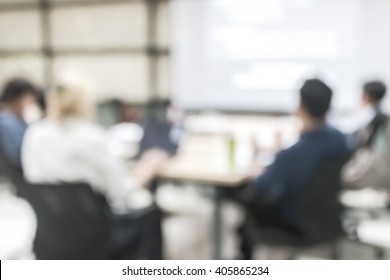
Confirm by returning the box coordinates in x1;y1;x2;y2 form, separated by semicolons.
0;78;36;168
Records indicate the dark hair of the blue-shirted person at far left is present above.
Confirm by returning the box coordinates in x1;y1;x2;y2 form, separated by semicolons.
1;78;36;103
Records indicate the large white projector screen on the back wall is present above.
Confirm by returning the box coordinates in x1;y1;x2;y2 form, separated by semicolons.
172;0;389;112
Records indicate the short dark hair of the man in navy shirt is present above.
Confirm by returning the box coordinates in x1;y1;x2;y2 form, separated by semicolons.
300;79;333;119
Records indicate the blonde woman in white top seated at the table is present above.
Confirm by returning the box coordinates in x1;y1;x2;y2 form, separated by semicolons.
22;85;166;259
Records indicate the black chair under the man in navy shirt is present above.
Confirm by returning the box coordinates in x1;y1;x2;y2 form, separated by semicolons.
242;157;348;259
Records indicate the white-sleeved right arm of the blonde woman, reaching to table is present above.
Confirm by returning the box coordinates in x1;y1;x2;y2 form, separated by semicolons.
78;129;165;211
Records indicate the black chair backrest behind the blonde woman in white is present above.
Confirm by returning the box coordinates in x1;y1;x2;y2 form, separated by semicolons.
2;152;110;260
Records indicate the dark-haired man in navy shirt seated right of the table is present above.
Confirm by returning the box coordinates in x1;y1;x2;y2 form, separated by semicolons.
241;79;349;259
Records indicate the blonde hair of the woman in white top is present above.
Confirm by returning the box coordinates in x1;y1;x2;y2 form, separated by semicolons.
47;85;92;122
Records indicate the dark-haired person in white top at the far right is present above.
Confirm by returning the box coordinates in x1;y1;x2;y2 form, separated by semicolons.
337;81;387;148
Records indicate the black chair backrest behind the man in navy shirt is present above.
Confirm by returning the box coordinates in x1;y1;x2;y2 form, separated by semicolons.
293;157;348;243
